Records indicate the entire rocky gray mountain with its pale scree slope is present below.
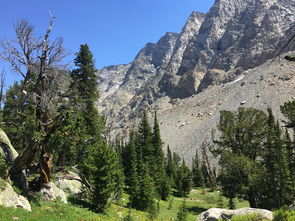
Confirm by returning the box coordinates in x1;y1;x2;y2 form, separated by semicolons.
98;0;295;160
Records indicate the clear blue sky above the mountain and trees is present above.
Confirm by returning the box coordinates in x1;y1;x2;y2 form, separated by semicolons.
0;0;214;88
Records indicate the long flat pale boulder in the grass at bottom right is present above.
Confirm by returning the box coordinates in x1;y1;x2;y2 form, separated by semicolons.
197;208;273;221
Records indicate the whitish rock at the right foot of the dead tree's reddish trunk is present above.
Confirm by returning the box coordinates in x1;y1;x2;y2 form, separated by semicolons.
41;182;68;203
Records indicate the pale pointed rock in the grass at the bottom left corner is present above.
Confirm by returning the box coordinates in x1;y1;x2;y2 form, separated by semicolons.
0;182;32;211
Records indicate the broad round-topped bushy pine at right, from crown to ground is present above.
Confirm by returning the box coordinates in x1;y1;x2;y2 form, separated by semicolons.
211;108;267;207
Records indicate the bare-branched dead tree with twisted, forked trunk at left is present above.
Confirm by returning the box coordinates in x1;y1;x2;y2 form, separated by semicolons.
0;16;66;187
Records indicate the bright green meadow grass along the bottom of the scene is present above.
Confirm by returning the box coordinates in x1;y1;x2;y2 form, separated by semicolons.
0;189;248;221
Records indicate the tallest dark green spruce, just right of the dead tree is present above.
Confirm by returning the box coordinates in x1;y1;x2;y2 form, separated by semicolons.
70;44;105;177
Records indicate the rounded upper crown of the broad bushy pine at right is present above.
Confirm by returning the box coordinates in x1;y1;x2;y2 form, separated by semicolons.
213;108;267;160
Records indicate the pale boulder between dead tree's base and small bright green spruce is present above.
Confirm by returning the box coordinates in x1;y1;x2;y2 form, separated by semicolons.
56;172;82;194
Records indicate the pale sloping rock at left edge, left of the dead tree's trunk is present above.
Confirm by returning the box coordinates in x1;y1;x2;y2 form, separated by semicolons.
0;129;18;163
